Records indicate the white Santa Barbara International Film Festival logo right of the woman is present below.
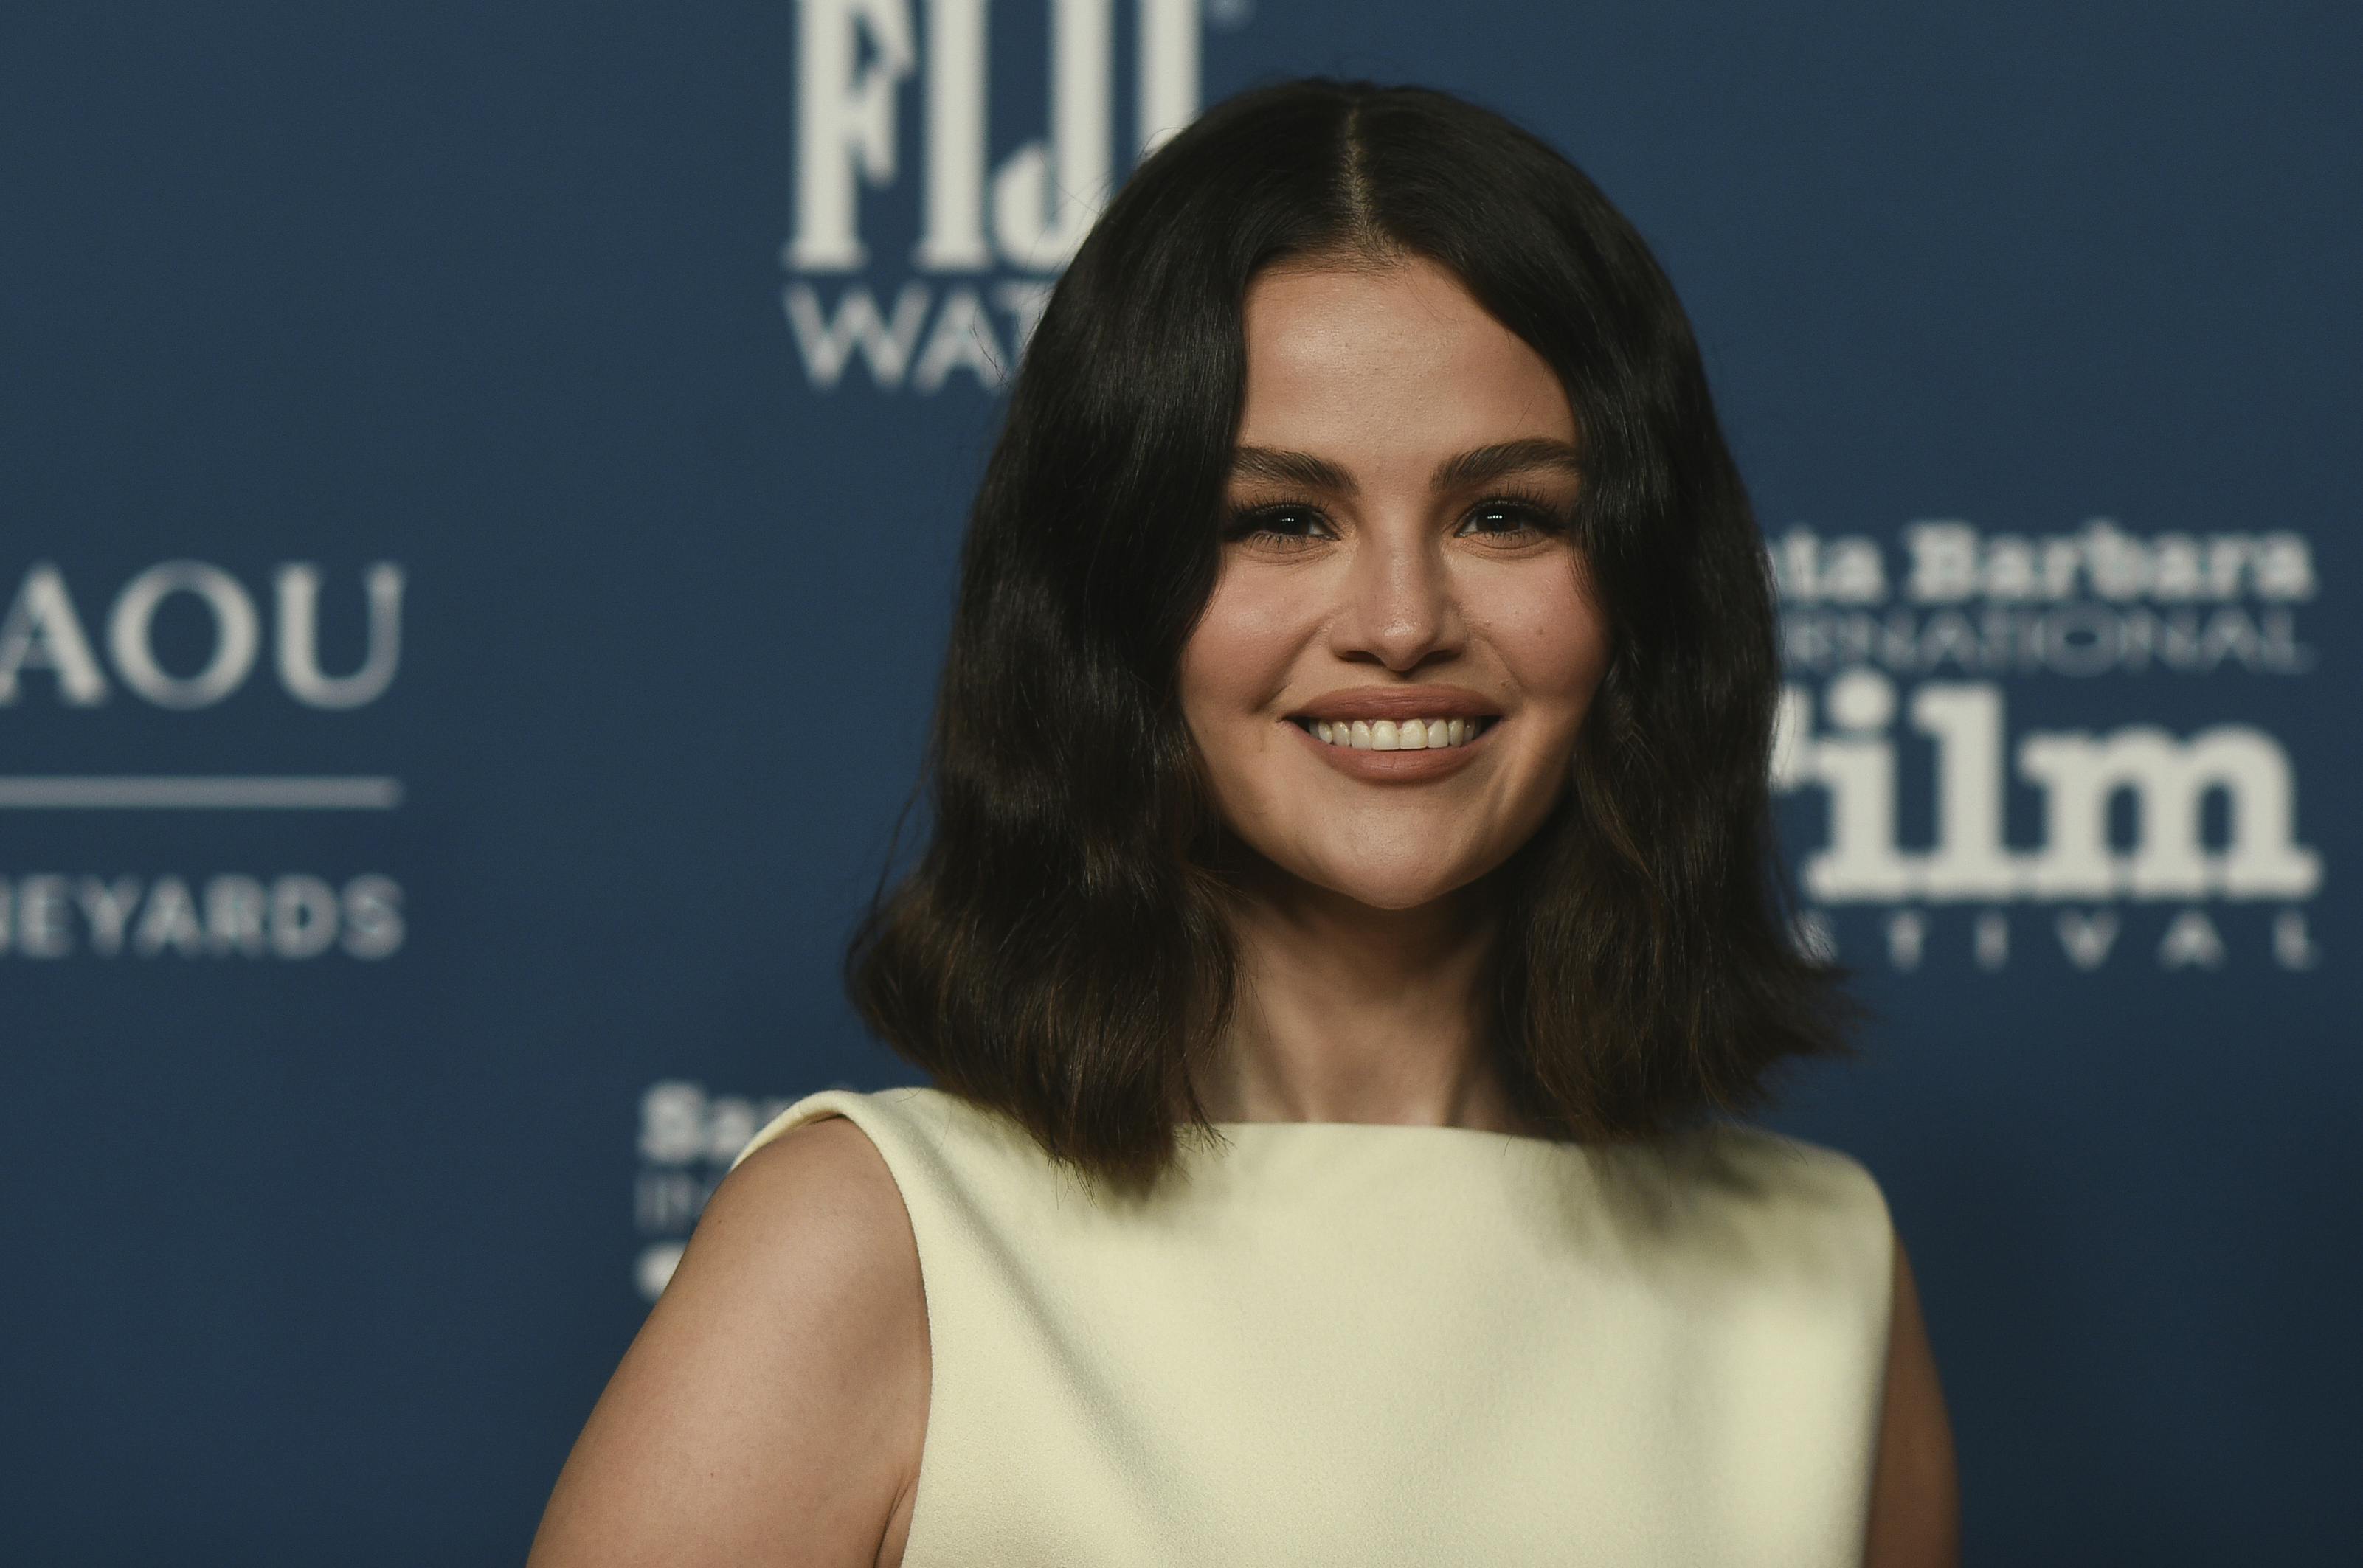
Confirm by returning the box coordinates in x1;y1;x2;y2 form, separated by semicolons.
1772;519;2323;971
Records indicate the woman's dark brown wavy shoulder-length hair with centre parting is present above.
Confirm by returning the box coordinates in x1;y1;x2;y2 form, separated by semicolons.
846;70;1850;1183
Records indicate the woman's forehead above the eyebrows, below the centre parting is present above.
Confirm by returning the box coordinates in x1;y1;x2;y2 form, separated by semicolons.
1238;257;1576;465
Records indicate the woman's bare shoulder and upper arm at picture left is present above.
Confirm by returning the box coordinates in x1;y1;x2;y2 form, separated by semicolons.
532;1117;929;1568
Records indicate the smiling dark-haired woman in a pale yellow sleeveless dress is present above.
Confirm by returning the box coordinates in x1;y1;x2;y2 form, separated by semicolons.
534;80;1954;1568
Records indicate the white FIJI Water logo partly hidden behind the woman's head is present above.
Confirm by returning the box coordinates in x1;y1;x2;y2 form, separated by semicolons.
780;0;1245;392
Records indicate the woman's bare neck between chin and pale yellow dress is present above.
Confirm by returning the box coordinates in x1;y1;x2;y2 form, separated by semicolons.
1196;867;1524;1131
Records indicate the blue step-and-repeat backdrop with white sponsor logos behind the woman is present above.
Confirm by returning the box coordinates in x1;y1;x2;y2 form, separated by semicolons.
0;0;2363;1566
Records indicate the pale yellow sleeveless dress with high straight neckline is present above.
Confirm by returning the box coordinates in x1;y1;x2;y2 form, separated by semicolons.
740;1089;1893;1568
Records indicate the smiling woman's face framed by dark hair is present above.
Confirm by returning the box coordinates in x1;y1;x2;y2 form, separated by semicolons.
1182;260;1609;909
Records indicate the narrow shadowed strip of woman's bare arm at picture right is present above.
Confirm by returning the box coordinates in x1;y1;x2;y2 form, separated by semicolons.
1862;1238;1961;1568
